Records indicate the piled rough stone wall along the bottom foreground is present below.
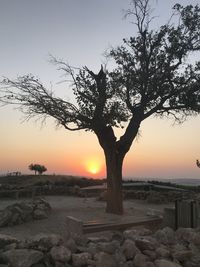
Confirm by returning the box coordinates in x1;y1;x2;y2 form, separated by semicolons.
0;228;200;267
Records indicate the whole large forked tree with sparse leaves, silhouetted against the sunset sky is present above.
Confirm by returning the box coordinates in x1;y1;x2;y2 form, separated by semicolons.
1;0;200;214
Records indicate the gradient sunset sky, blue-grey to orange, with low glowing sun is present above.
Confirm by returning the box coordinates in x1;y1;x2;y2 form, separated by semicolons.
0;0;200;178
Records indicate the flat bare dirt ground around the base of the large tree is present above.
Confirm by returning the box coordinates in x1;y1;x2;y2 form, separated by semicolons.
0;196;173;242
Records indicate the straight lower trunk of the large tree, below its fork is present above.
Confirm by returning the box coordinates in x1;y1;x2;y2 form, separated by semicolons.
104;150;124;214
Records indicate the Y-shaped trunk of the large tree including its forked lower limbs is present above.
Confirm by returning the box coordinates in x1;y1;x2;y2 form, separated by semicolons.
95;119;141;214
